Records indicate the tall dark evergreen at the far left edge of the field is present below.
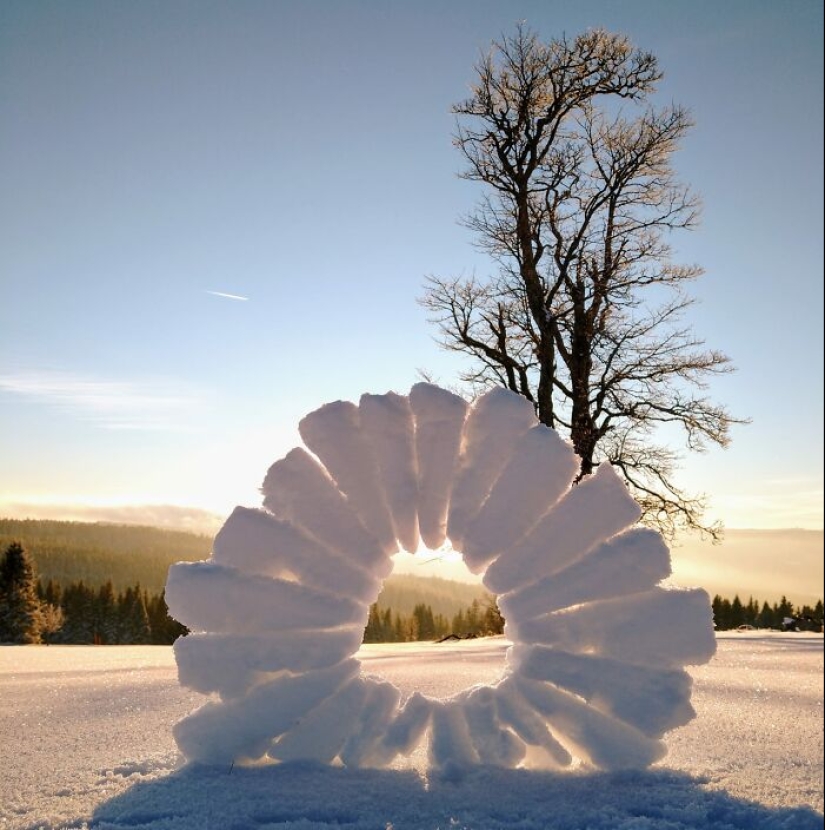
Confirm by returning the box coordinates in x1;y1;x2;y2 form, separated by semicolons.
0;542;43;643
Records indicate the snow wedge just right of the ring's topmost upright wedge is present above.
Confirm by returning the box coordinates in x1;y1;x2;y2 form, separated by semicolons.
447;387;536;550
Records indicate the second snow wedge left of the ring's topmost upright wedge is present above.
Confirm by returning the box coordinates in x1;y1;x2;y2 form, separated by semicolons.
298;401;398;555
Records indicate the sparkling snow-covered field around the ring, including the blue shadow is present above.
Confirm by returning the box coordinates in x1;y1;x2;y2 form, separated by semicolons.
0;632;823;830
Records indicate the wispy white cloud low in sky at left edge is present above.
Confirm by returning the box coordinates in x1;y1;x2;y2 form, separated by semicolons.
0;371;209;432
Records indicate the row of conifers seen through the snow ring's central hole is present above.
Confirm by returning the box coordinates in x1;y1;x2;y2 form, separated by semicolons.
364;600;504;643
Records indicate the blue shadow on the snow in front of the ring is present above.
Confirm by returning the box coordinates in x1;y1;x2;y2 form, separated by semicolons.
90;763;823;830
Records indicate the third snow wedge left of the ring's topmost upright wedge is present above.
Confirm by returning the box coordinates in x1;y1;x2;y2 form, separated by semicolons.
261;447;392;579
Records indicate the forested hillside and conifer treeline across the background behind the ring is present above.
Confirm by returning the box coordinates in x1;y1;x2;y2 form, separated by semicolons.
0;519;823;643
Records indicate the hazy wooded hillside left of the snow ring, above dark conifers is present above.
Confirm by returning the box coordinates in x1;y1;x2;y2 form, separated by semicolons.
0;519;212;593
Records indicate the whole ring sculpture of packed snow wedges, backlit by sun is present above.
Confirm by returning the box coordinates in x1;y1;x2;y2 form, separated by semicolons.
166;383;715;771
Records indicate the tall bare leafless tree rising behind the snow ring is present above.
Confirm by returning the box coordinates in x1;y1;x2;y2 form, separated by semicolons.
421;27;736;537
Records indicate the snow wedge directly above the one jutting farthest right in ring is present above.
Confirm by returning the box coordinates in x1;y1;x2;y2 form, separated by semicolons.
498;527;670;630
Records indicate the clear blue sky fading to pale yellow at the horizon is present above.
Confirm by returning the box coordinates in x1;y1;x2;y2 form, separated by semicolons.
0;0;823;544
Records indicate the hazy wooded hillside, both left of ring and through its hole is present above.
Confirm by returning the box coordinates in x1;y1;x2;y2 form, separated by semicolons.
0;519;487;618
